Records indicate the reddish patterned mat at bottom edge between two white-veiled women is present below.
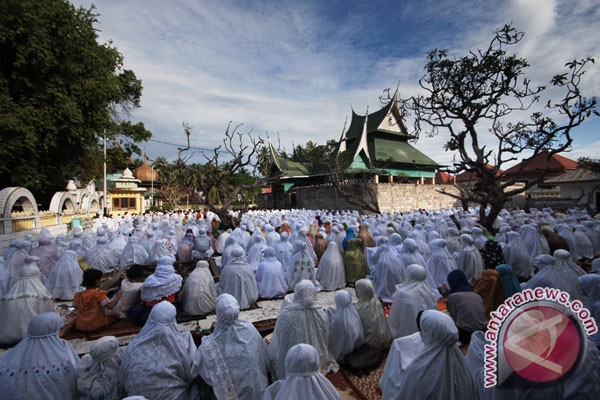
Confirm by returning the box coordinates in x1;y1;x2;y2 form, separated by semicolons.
327;360;385;400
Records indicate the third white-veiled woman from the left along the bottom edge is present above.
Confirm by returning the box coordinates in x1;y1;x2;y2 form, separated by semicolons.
119;301;196;400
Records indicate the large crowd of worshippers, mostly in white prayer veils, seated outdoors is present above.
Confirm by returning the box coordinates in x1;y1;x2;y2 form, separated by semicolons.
0;209;600;400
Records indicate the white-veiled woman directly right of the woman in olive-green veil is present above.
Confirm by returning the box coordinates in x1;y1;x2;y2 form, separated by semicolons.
371;244;408;301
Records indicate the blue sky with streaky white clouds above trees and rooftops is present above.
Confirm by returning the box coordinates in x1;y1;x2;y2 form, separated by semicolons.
72;0;600;168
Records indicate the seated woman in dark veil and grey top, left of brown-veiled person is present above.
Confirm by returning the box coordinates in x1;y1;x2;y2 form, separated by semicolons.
446;269;488;344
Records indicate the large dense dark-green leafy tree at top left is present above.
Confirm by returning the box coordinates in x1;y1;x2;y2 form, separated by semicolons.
0;0;151;198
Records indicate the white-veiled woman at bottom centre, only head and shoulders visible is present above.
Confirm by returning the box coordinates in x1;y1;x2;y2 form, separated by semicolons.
262;343;341;400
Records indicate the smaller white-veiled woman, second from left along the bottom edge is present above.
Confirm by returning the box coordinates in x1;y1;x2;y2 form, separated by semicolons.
77;336;125;400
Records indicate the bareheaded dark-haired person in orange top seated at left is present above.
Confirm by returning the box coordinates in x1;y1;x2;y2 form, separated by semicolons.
73;269;122;332
